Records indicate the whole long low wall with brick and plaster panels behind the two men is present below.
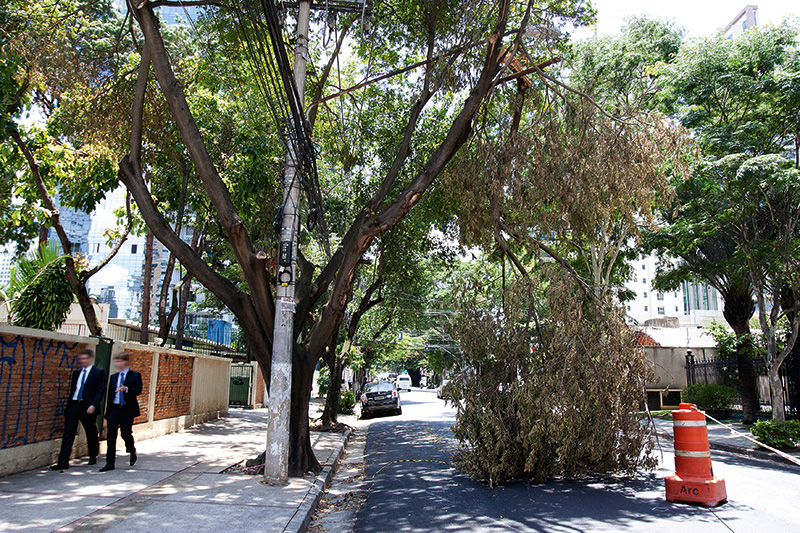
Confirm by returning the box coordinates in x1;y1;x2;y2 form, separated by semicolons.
0;324;230;476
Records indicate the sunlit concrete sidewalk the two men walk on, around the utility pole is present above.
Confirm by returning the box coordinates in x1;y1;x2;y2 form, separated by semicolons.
0;410;347;533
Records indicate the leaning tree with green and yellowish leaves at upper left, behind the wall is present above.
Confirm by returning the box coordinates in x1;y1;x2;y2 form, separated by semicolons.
0;0;131;335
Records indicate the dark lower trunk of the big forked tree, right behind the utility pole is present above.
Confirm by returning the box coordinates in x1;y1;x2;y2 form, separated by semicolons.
289;345;322;477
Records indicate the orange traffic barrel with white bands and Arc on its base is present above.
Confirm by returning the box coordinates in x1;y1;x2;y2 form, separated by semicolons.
666;403;728;507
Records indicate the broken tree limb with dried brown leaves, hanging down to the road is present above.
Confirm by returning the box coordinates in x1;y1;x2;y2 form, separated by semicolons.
438;15;687;483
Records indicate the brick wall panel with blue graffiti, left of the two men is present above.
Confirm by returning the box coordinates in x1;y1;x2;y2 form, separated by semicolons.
0;333;94;449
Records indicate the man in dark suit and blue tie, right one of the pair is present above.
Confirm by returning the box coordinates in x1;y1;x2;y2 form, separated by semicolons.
100;352;142;472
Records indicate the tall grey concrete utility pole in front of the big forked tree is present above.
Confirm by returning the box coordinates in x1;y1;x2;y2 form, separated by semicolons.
264;0;311;484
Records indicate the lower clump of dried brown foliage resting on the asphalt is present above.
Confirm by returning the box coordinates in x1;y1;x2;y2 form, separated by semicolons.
446;276;655;486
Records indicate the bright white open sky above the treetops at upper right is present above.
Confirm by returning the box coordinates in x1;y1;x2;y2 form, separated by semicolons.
574;0;800;39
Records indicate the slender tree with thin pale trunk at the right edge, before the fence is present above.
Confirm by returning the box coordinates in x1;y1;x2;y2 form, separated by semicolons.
695;154;800;422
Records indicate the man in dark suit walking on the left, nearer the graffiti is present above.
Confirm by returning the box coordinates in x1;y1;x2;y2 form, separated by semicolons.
50;349;106;470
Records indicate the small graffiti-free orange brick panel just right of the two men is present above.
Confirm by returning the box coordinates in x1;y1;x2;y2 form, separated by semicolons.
153;353;194;420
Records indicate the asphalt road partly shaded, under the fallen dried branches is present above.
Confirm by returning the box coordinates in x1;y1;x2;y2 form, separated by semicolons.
355;390;800;533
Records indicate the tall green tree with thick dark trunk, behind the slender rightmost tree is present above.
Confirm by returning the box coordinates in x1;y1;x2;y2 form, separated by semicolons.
650;20;800;422
